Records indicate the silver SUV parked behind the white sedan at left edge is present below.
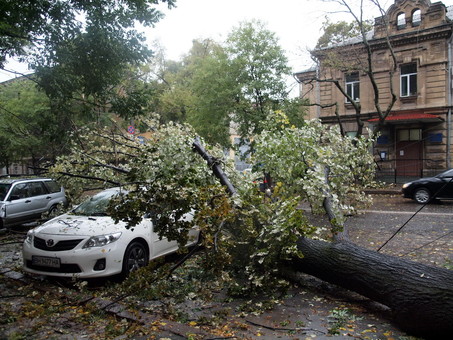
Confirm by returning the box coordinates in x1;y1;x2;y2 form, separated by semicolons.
0;178;67;229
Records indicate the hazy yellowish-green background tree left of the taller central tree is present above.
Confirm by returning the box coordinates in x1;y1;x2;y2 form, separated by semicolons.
144;39;235;147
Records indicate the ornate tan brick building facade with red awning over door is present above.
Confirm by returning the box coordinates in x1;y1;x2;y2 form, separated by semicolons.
295;0;453;178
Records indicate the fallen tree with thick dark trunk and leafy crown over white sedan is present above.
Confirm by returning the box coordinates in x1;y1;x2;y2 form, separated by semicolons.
53;117;453;338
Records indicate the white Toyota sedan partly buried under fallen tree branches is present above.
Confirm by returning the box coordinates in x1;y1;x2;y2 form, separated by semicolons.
22;188;199;278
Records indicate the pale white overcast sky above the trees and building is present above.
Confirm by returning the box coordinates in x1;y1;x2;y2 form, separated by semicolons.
0;0;453;81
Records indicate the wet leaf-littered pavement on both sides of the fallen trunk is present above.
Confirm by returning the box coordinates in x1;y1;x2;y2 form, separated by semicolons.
0;193;453;339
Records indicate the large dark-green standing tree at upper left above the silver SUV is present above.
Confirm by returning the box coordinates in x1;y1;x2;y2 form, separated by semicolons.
0;0;174;170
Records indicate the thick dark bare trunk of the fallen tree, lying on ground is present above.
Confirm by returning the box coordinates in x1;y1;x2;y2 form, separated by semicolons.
290;238;453;339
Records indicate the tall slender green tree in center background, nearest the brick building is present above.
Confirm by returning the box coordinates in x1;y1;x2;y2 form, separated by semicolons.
227;21;290;138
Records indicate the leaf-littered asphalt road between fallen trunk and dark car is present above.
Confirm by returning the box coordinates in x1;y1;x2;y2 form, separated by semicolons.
346;195;453;268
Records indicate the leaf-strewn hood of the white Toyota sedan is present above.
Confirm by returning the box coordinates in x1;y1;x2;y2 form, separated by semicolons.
34;214;126;236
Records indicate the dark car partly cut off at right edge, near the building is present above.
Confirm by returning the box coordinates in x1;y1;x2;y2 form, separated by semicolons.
403;169;453;204
